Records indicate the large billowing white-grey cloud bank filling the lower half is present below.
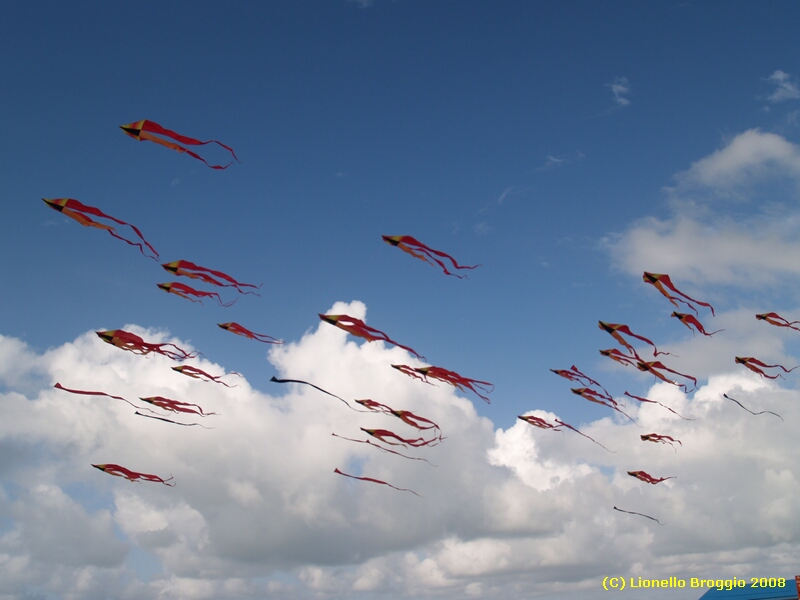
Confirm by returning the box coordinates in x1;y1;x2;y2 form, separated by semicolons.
0;302;800;599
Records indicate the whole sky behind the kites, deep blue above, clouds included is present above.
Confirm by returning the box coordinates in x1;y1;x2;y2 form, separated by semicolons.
0;0;800;598
